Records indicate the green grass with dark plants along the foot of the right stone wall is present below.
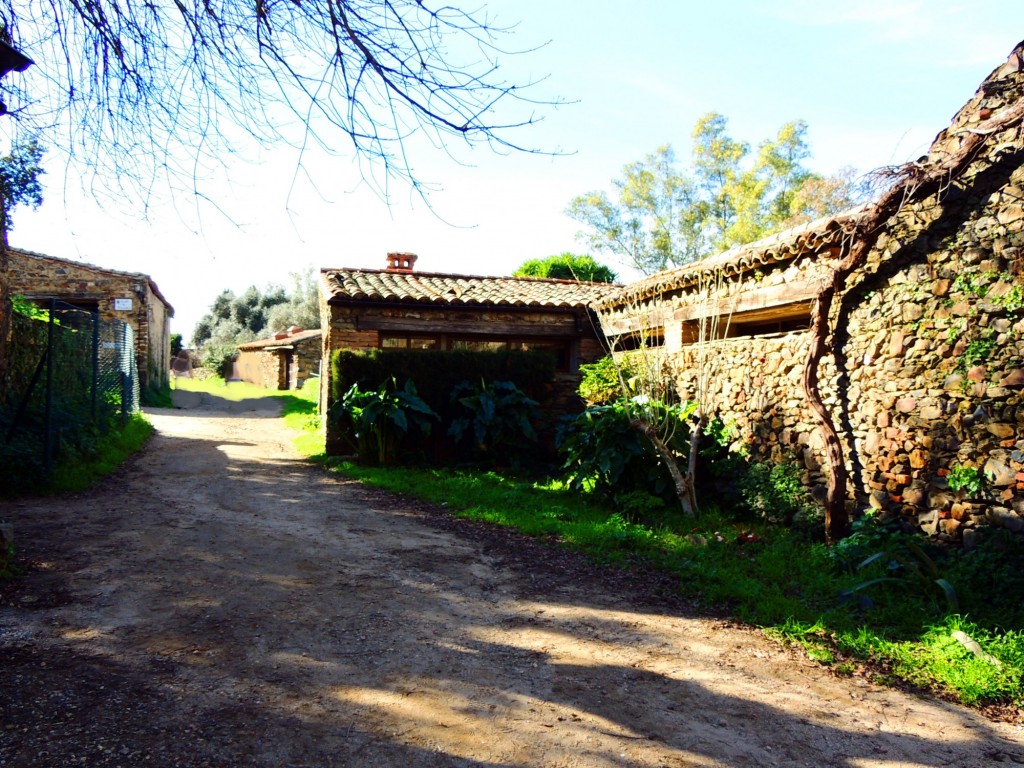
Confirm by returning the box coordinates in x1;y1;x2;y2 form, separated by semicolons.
336;462;1024;707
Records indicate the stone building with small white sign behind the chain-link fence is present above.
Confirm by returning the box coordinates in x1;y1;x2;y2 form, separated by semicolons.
7;248;174;388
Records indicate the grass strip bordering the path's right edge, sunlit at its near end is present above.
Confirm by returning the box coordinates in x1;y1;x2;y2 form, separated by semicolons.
329;463;1024;705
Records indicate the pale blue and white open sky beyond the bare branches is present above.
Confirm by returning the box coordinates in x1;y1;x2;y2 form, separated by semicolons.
11;0;1024;338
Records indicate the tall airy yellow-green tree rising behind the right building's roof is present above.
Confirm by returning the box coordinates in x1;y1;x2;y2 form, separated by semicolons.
566;113;865;274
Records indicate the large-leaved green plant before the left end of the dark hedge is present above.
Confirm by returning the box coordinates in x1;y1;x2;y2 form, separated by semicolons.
330;378;438;466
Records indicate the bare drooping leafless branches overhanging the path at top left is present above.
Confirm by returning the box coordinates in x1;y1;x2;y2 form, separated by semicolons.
0;0;552;202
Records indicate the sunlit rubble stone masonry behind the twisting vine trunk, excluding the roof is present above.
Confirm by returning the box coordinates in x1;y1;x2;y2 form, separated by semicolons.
634;54;1024;544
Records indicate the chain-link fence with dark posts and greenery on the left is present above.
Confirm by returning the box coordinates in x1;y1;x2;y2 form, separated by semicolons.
0;301;139;490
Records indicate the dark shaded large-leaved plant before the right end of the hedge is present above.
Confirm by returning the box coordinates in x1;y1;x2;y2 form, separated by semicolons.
449;381;540;457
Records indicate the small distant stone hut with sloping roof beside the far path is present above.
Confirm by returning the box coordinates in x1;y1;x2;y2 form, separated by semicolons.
238;327;323;389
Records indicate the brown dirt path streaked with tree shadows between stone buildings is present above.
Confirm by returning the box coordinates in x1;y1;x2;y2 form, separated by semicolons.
0;392;1024;768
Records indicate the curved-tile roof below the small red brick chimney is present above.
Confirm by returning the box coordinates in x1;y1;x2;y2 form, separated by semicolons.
321;269;621;309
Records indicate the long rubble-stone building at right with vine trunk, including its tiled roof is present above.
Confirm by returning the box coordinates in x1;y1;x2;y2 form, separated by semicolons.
595;48;1024;539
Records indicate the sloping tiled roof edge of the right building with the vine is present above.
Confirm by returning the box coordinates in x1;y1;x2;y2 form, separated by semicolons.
595;206;866;309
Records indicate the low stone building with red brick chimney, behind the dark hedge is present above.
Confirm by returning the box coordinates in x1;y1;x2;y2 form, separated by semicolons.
321;253;616;454
